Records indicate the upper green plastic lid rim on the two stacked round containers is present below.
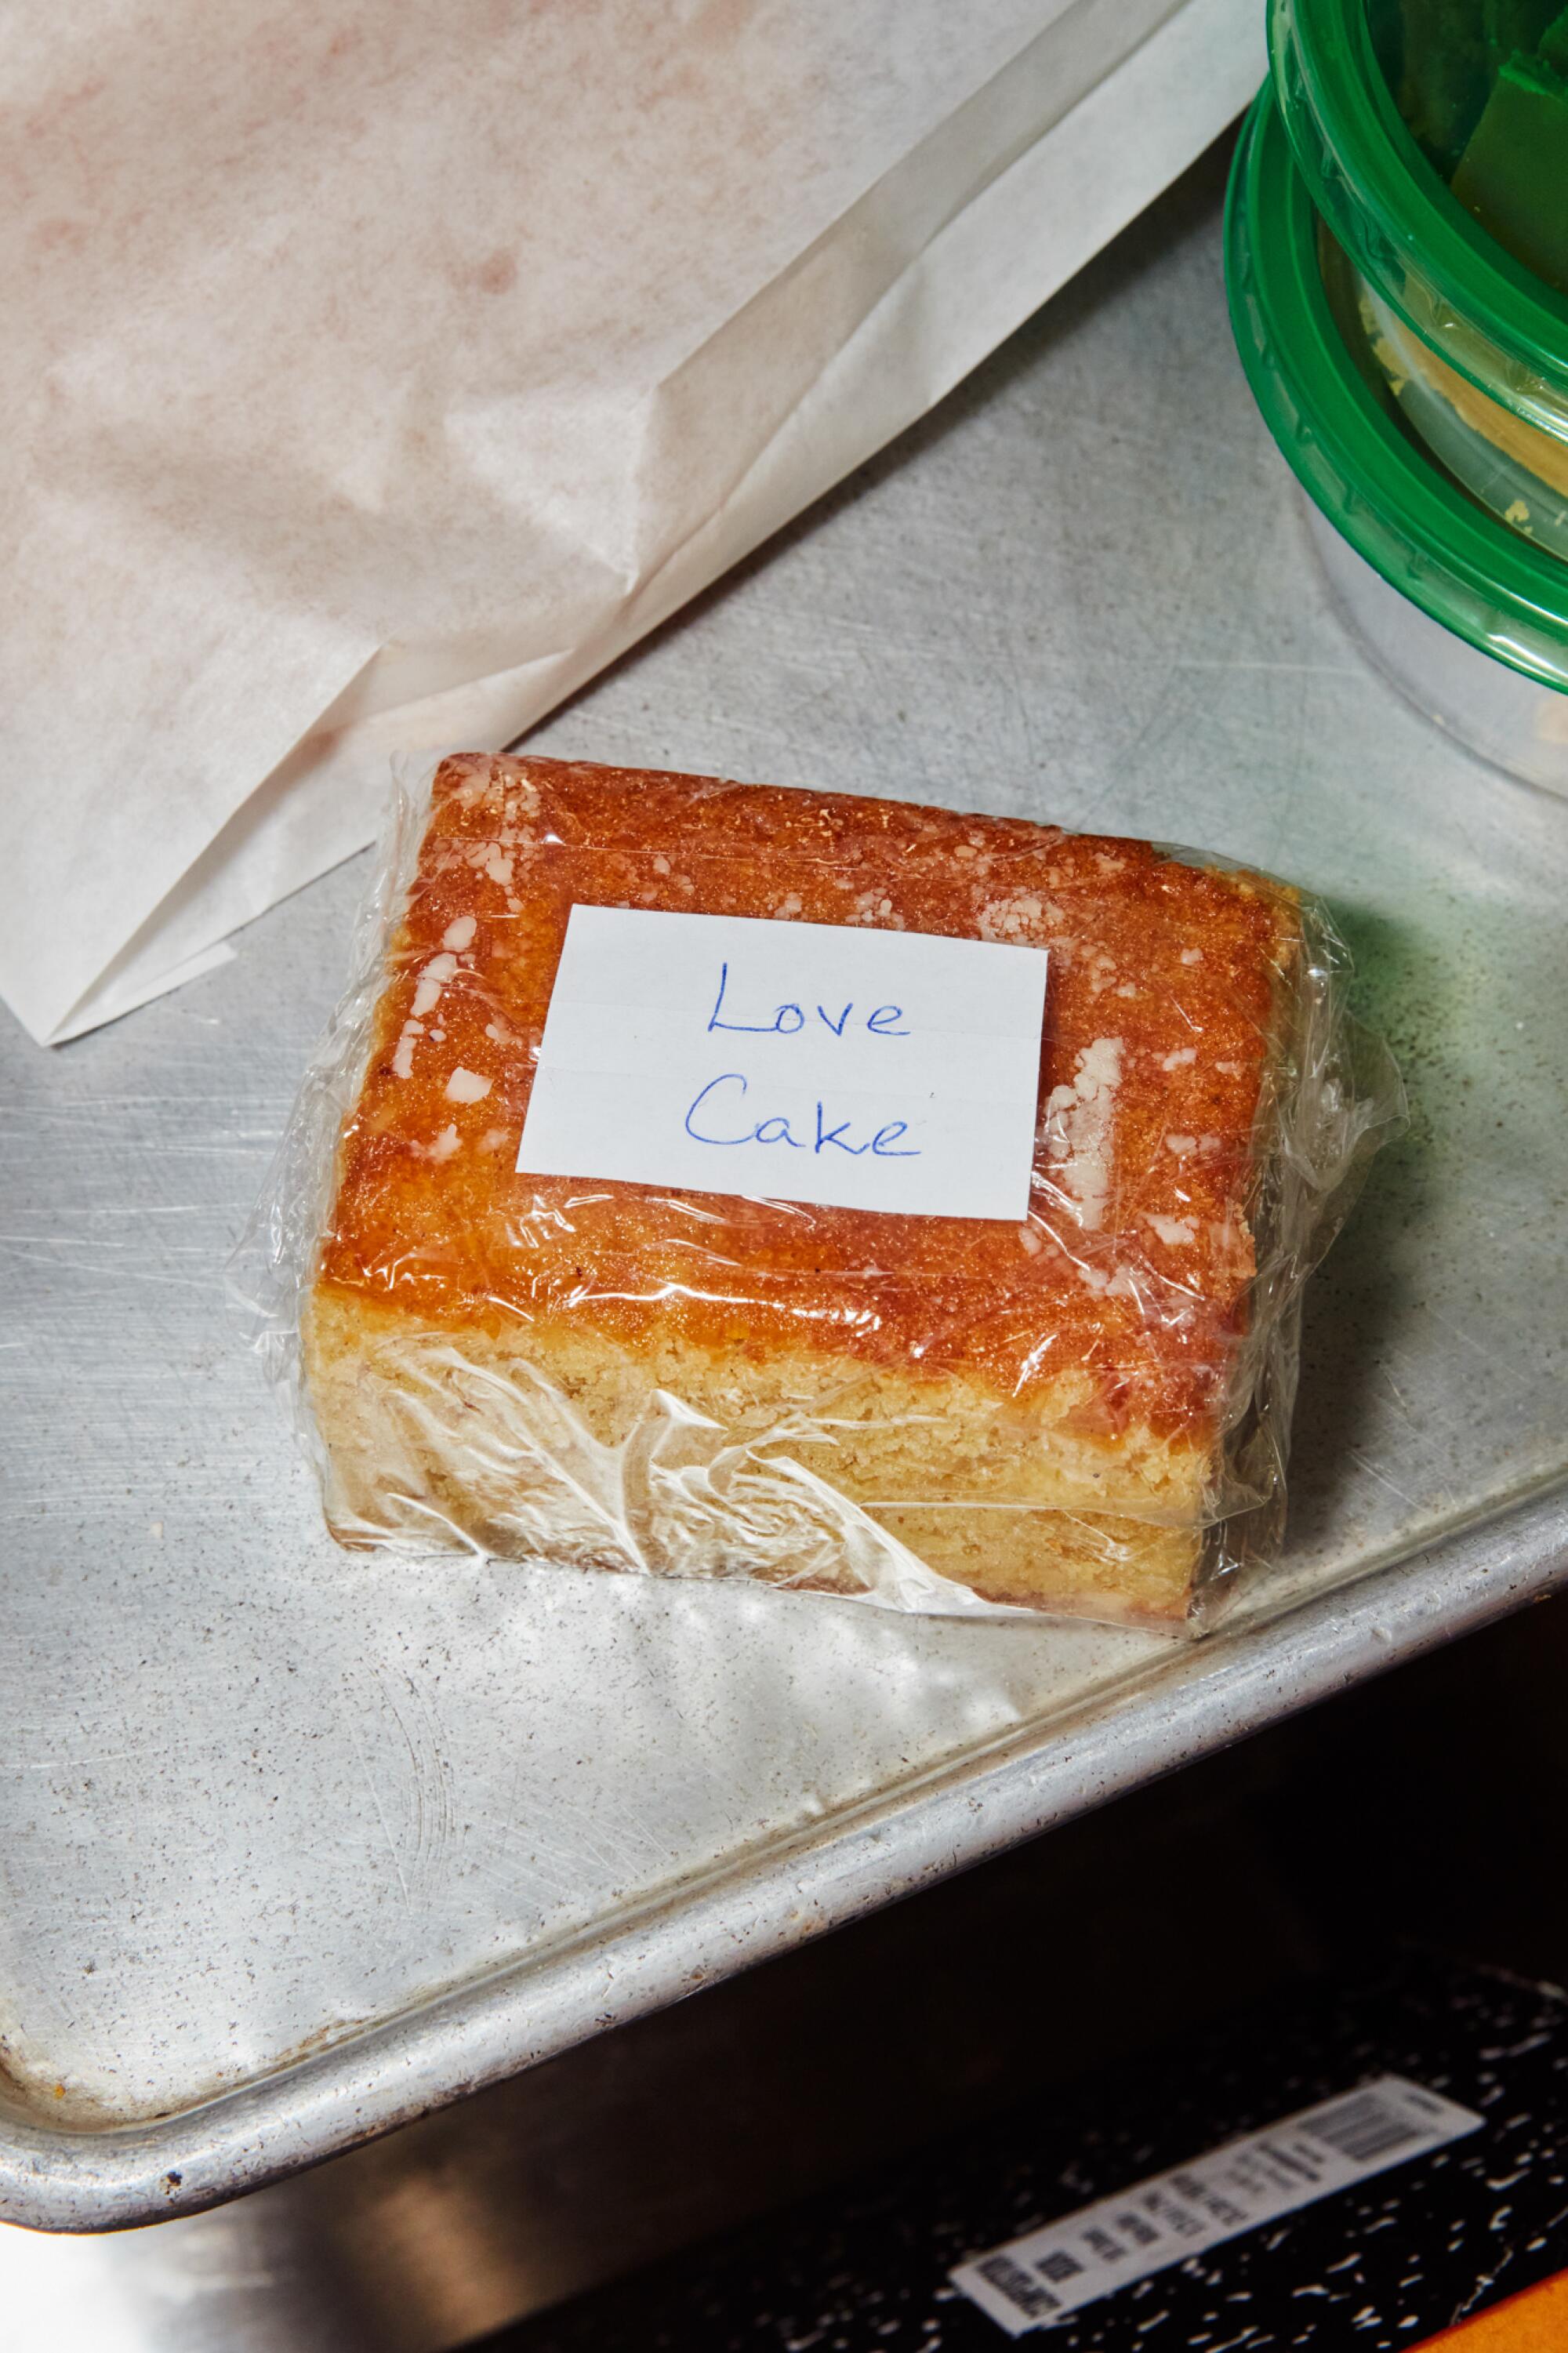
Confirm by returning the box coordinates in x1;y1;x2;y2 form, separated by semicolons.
1269;0;1568;440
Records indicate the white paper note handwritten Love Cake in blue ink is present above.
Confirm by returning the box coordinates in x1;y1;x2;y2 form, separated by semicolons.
518;906;1045;1222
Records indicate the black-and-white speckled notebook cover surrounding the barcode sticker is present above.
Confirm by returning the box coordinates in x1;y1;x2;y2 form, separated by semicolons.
494;1958;1568;2353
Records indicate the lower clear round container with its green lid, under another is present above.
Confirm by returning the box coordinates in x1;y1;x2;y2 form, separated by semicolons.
1227;87;1568;793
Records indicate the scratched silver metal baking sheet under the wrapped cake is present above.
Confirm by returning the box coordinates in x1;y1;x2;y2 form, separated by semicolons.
0;137;1568;2231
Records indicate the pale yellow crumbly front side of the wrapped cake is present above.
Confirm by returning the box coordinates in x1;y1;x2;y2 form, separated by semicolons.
303;1287;1210;1631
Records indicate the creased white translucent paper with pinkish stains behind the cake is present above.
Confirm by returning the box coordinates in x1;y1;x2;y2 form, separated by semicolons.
0;0;1262;1040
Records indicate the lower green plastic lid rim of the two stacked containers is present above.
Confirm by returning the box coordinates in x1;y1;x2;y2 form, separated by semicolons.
1225;87;1568;692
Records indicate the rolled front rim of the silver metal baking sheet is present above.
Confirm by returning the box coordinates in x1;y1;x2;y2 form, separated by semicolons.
0;1476;1568;2233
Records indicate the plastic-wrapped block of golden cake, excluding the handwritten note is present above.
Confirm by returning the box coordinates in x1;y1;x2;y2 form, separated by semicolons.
235;755;1403;1629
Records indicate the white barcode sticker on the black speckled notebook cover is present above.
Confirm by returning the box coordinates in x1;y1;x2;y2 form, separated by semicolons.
951;2075;1486;2337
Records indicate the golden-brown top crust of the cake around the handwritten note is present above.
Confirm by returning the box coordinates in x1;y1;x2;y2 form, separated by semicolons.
320;755;1300;1438
